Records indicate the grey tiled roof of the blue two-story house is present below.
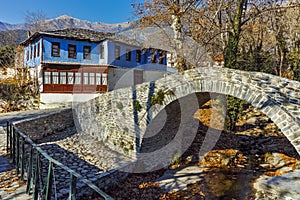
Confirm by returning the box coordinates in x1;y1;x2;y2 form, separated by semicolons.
21;28;141;46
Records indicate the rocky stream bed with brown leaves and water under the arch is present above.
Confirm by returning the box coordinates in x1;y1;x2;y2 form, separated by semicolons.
102;101;300;199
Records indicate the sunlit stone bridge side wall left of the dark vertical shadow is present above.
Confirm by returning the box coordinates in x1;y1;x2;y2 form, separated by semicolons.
73;89;136;156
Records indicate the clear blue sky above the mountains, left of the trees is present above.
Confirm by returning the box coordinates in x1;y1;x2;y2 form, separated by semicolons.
0;0;138;24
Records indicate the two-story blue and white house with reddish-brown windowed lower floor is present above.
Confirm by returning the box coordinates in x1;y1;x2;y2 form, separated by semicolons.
21;29;167;103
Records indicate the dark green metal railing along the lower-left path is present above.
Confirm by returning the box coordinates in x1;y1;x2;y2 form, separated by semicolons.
6;121;113;200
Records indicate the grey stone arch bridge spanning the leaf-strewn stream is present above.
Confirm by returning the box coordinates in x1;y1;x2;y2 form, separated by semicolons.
73;67;300;162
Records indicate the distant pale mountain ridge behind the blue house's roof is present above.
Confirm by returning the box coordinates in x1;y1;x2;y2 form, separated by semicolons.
0;15;131;33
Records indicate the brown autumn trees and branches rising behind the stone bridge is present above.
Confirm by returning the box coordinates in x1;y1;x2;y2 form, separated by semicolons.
132;0;300;78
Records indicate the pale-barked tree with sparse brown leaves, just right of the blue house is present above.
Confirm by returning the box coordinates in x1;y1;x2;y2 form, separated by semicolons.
132;0;201;72
